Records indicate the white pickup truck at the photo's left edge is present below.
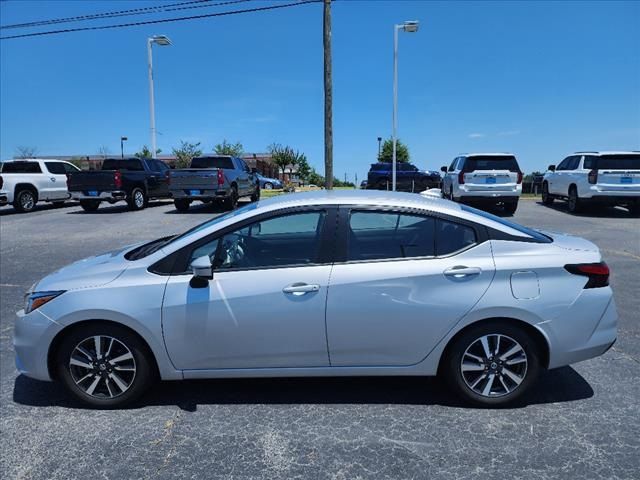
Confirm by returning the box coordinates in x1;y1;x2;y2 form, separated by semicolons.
0;158;80;212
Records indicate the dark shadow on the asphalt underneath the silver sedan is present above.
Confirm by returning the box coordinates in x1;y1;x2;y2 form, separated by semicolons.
13;367;593;412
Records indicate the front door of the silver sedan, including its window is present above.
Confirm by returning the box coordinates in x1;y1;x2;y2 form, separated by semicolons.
162;210;335;370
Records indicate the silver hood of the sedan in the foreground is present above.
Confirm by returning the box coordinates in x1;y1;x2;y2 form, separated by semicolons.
32;243;142;292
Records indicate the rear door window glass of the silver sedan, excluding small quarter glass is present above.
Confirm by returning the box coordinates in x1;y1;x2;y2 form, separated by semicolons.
347;211;435;261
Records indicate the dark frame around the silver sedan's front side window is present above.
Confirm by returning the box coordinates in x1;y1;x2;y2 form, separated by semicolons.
152;205;337;276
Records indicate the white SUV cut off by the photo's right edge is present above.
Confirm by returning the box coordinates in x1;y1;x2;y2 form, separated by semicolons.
542;152;640;215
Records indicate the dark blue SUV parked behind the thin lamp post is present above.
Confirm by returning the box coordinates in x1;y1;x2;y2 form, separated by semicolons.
367;162;441;192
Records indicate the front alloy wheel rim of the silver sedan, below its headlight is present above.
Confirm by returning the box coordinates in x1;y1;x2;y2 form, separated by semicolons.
69;335;136;399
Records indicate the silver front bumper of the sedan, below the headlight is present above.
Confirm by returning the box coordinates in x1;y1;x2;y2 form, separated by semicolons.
13;310;63;381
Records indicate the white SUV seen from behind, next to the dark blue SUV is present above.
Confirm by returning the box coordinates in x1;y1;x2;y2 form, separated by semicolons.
440;153;522;214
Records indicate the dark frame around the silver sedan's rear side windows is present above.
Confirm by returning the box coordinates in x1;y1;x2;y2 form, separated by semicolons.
333;205;489;265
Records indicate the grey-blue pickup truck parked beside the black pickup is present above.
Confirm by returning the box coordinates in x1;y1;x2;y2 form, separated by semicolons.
170;155;260;212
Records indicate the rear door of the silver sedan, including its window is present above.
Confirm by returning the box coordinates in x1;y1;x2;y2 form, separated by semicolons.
327;208;495;366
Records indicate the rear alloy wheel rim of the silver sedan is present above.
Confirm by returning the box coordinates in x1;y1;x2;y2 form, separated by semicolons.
460;334;528;398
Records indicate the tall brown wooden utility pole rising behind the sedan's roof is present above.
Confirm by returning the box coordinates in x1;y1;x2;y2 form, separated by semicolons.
322;0;333;190
